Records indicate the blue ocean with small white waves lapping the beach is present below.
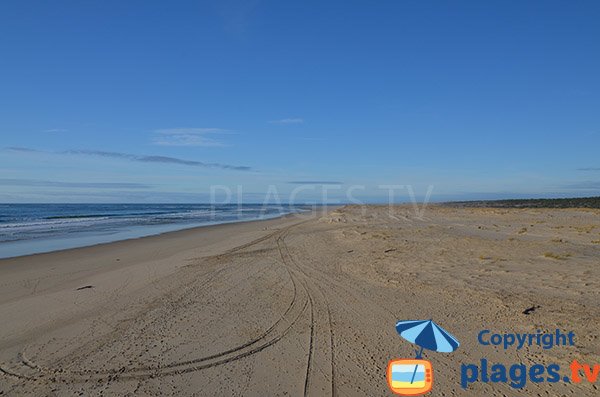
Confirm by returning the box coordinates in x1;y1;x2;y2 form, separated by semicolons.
0;204;306;258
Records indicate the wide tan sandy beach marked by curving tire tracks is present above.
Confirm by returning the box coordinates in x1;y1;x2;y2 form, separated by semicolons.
0;206;600;396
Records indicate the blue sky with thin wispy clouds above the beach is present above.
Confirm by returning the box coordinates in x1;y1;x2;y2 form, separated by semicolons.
0;0;600;203
